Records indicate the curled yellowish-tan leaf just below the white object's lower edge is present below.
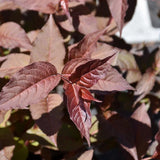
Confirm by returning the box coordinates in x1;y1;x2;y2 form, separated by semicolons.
117;52;141;83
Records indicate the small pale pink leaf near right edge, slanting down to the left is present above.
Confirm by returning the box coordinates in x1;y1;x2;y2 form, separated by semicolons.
134;68;156;95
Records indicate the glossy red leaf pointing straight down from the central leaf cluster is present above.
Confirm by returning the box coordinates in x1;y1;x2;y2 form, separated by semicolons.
65;84;91;145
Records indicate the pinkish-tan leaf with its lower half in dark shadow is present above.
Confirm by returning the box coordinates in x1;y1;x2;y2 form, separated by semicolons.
30;94;63;145
